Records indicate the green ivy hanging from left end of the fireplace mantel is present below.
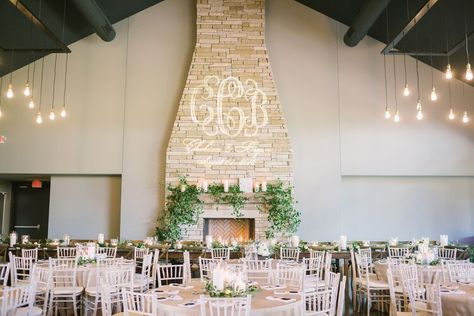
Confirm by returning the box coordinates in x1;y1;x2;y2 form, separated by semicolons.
156;176;203;241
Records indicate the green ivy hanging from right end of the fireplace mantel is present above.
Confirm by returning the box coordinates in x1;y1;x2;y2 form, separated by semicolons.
258;181;301;238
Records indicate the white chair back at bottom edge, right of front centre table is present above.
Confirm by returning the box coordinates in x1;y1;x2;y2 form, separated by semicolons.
301;288;337;316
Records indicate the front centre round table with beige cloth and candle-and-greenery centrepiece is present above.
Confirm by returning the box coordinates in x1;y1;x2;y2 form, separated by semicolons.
116;279;302;316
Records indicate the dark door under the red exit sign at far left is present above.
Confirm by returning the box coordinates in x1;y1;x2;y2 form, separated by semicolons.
10;181;49;242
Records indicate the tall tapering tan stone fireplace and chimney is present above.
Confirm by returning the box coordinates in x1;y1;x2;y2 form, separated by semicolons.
166;0;293;240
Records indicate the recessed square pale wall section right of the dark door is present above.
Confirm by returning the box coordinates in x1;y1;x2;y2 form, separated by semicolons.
48;176;121;239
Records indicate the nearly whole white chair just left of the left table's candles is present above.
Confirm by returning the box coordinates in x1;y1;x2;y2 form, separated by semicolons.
49;258;84;316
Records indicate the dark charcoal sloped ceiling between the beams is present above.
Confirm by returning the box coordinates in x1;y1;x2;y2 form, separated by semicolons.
0;0;474;85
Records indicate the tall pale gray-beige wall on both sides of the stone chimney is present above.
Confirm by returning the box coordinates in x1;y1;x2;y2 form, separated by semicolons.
0;0;474;240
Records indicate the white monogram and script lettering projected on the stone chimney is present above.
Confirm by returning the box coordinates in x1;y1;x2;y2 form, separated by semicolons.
183;76;268;168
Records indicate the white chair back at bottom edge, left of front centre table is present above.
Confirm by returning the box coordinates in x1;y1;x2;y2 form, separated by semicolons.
122;289;157;316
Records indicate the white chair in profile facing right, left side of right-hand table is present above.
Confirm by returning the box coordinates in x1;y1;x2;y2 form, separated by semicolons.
355;253;389;315
